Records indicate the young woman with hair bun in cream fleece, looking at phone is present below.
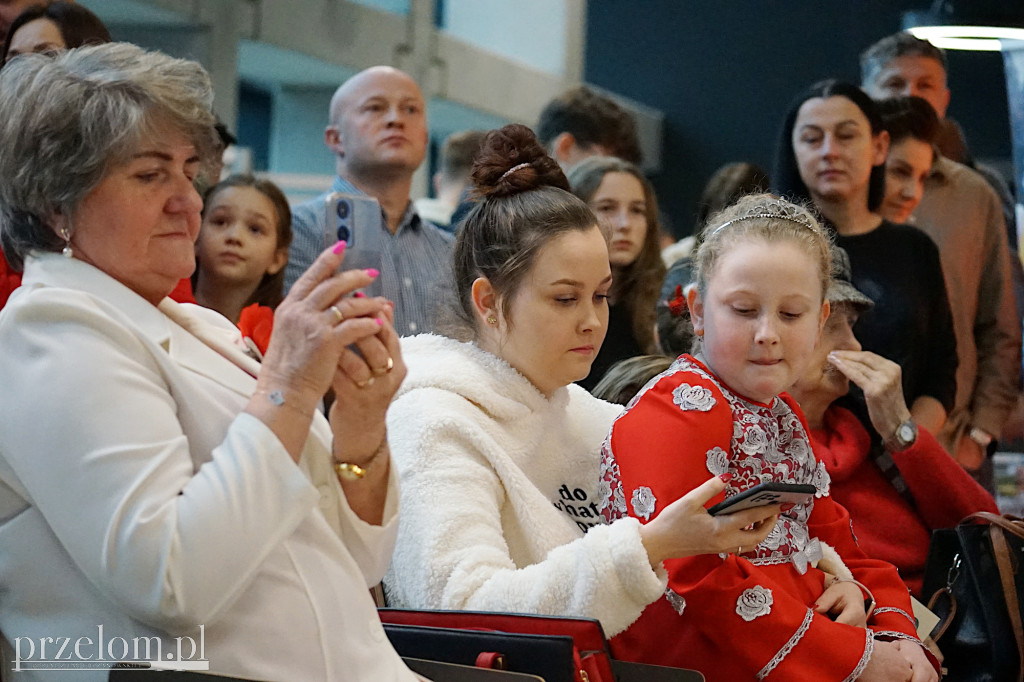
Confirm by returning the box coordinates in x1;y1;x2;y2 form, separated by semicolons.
385;125;778;635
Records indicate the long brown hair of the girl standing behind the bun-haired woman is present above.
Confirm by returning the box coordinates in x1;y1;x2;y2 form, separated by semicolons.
568;157;665;352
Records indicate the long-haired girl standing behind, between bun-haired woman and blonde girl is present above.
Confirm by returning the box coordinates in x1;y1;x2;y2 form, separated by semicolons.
568;157;665;390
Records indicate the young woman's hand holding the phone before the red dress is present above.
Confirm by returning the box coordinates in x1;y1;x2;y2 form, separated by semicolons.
640;477;779;566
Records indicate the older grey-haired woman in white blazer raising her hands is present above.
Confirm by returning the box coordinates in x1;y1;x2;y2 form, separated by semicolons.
0;44;416;680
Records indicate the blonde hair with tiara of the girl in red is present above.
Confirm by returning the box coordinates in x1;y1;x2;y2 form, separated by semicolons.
693;194;831;300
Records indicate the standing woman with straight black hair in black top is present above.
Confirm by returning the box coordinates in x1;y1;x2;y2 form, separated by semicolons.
774;80;956;433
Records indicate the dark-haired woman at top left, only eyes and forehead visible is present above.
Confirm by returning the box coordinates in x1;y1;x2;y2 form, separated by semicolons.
2;0;111;63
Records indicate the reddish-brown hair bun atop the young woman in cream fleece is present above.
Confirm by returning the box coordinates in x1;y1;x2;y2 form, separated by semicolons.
472;123;569;198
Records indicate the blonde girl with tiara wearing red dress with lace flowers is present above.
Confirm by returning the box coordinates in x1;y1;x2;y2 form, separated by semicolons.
602;195;938;682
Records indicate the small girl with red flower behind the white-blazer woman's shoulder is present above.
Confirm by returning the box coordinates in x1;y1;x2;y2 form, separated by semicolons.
193;175;292;356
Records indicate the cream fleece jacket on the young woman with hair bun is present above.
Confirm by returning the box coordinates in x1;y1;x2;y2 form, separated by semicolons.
384;335;667;637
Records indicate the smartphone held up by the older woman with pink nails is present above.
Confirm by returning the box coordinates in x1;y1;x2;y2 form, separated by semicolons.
324;191;386;296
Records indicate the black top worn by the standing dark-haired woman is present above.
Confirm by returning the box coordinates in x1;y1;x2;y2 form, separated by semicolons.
836;220;957;412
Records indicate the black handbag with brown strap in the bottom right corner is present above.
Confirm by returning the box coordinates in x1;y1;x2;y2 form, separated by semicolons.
922;512;1024;682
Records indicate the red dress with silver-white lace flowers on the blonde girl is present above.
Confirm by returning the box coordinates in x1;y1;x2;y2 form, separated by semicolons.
602;355;937;681
